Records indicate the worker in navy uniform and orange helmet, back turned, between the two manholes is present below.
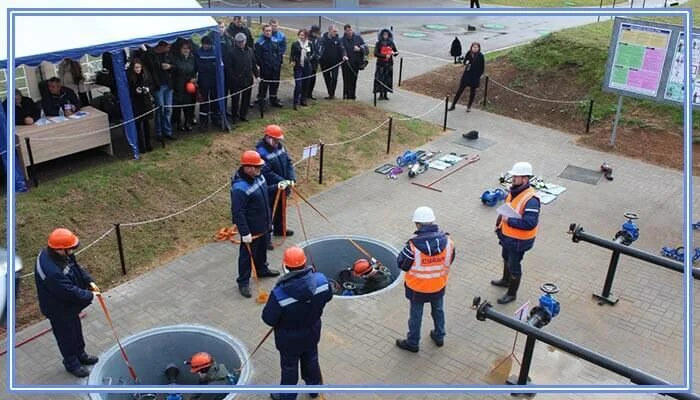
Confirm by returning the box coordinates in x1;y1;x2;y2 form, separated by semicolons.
262;247;333;400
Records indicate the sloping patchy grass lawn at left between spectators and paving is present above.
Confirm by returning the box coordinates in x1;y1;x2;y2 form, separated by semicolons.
0;101;442;325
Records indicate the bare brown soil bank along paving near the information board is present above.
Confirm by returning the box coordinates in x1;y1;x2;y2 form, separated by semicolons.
401;58;700;175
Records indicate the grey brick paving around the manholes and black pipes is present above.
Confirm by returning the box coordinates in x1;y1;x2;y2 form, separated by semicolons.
0;7;700;399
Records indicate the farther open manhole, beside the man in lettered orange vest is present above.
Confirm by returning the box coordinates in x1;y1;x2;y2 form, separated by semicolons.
299;235;402;298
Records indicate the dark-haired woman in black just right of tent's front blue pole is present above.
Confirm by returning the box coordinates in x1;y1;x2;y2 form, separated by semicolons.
127;58;155;153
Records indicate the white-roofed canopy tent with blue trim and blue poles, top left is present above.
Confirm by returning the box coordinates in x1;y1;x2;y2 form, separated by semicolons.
0;0;225;191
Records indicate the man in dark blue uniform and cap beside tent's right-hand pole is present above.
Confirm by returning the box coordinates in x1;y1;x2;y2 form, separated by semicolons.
194;36;221;129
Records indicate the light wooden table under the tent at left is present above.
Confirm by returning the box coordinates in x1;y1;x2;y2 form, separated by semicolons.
15;106;114;176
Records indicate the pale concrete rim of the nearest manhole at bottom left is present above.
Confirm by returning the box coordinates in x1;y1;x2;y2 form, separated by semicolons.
86;324;253;400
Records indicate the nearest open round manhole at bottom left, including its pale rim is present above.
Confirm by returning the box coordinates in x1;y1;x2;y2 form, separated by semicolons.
87;325;252;400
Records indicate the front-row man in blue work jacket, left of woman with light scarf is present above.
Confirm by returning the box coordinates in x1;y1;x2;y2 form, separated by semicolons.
255;25;284;107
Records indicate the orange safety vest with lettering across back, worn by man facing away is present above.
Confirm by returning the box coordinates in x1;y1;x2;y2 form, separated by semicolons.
405;238;454;293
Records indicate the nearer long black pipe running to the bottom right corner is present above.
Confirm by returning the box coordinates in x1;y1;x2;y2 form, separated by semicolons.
475;299;700;400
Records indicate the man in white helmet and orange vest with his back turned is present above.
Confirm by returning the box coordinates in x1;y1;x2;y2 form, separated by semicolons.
396;207;455;353
